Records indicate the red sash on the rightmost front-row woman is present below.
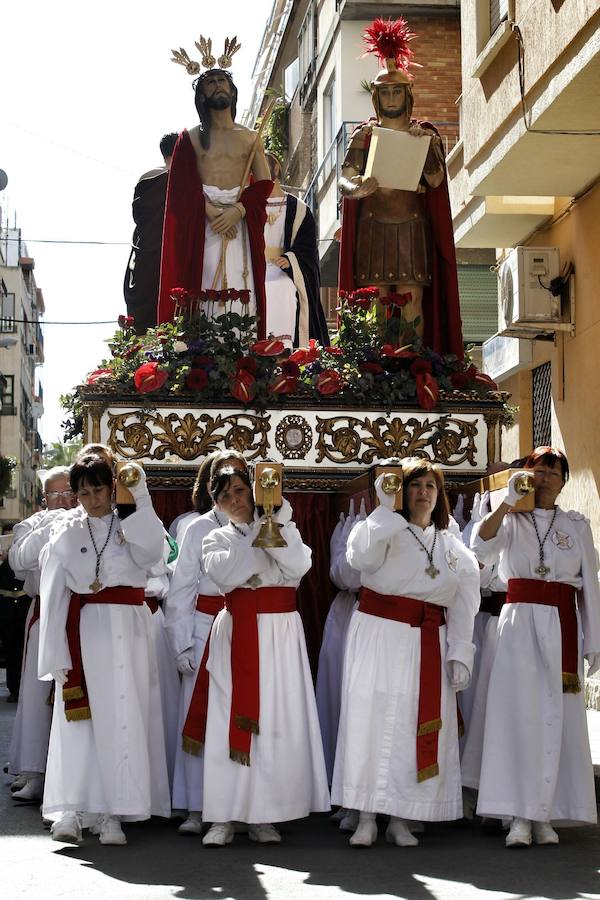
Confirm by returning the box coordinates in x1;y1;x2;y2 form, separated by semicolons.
506;578;581;694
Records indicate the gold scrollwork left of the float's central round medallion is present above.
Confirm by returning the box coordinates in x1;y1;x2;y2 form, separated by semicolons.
107;410;270;461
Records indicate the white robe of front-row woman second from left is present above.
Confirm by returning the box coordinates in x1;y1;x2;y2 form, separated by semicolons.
202;501;330;824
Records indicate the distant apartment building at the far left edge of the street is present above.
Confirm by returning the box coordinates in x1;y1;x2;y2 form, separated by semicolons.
0;221;44;530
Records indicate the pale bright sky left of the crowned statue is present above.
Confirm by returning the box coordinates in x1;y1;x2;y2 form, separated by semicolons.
0;0;273;443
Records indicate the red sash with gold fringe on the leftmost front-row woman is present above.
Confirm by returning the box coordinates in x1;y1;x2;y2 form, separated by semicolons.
62;586;144;722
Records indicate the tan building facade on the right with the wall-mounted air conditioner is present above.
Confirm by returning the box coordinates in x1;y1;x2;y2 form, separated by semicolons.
448;0;600;545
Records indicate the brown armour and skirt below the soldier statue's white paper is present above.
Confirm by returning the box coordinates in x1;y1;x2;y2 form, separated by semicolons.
355;190;431;286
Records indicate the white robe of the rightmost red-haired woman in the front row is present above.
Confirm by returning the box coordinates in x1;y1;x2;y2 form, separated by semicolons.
472;509;600;824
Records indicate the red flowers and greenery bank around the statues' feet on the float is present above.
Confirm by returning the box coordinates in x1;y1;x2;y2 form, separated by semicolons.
64;288;497;430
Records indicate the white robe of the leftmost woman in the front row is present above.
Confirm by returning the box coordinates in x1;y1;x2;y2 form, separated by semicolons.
38;504;170;825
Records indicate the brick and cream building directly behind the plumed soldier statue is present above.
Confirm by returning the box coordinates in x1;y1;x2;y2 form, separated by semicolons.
245;0;495;343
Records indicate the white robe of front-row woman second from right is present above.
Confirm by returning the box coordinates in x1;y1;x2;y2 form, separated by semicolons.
332;506;479;821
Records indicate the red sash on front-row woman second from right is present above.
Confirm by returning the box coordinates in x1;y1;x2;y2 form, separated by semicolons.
358;588;446;782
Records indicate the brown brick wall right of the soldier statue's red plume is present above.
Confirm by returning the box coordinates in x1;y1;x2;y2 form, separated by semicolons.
407;12;461;152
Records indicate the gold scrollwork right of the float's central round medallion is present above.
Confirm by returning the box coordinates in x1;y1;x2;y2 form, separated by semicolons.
316;415;477;466
